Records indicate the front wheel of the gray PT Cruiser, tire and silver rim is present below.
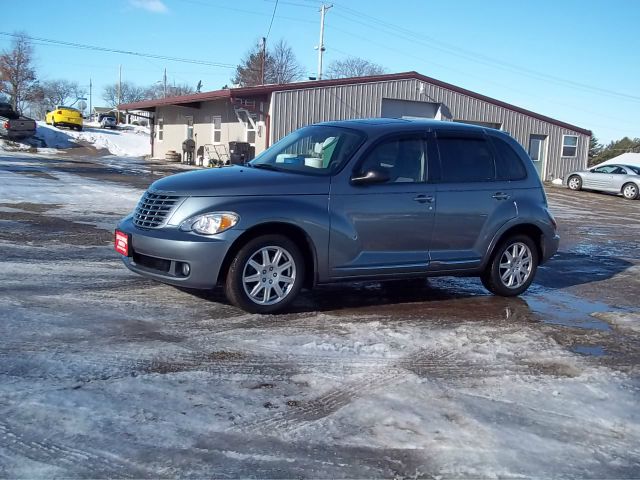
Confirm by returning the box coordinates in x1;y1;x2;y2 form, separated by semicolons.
225;235;305;313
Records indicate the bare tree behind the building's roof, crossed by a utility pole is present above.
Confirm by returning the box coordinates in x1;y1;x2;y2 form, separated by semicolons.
231;40;304;87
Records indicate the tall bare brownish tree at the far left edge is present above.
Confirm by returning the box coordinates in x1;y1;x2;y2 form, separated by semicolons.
0;33;36;111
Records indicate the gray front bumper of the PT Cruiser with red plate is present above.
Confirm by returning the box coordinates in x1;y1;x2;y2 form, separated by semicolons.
117;217;242;289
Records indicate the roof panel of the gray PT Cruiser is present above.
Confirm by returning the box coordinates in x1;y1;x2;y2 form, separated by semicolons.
316;118;498;136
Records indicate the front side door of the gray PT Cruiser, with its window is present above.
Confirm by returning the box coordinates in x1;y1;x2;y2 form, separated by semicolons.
329;133;435;279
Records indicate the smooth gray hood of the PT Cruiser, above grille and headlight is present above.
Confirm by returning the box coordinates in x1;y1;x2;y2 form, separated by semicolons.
149;166;330;197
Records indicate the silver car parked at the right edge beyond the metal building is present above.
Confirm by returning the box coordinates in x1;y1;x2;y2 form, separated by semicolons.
567;164;640;200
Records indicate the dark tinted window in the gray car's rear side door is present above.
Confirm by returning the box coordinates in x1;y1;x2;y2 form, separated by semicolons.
438;137;495;183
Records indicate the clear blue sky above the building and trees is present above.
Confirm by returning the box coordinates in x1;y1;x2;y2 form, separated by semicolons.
0;0;640;142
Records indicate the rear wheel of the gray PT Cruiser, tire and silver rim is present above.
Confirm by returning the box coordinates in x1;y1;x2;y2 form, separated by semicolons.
480;235;539;297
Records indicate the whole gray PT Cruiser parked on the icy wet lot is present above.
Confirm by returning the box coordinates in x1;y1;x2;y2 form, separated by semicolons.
115;119;559;313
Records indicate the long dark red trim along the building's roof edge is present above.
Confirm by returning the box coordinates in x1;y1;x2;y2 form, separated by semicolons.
119;71;592;136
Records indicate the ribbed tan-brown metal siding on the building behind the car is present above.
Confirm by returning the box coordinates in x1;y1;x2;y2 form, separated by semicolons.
271;79;589;180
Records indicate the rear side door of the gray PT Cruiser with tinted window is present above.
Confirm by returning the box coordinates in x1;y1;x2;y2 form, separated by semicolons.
430;129;517;271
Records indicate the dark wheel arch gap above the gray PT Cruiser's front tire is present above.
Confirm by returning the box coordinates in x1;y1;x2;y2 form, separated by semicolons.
217;222;318;288
